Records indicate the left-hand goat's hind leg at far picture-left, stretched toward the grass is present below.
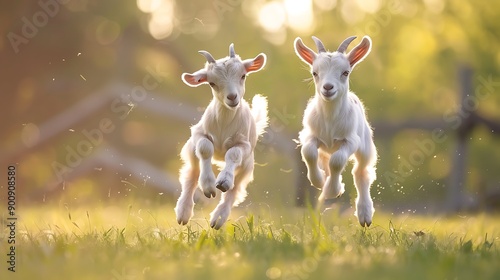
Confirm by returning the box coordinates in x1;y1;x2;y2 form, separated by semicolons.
174;139;200;225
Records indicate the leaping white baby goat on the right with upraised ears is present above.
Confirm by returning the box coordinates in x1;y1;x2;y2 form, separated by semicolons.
294;36;377;227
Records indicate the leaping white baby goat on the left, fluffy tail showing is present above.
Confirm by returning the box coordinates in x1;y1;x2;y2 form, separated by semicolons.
175;44;268;229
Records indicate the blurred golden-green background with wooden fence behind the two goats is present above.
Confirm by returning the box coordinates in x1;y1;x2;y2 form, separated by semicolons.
0;0;500;213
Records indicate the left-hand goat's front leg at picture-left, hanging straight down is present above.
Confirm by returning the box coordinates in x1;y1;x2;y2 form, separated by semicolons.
196;137;215;198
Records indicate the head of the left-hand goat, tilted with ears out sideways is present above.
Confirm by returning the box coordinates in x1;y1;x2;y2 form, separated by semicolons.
182;44;266;109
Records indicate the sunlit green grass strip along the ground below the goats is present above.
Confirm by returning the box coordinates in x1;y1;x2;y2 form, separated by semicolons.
0;201;500;280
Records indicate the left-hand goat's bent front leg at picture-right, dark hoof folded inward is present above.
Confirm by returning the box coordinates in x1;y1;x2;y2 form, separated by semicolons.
215;143;251;192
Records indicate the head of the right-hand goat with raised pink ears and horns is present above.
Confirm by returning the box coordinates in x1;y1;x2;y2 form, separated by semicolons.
294;36;371;101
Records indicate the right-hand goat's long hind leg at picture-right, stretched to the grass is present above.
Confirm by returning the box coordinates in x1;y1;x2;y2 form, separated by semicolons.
352;143;377;227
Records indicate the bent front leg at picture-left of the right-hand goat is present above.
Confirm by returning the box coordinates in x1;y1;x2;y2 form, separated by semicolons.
300;138;325;189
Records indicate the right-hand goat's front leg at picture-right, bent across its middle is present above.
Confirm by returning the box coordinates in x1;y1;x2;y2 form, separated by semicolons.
319;139;359;201
